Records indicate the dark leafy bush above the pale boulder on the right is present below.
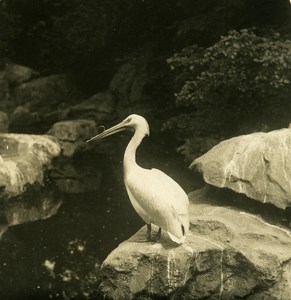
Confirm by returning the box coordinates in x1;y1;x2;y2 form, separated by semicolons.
166;29;291;159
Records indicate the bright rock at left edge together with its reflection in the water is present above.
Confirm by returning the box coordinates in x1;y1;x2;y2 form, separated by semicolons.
0;134;61;239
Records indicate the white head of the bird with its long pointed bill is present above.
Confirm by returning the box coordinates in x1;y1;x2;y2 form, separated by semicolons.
87;114;150;143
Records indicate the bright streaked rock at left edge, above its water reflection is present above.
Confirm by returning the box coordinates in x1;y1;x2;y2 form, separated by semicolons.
0;134;60;200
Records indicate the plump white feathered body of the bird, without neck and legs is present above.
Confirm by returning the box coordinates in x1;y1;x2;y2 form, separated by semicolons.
124;166;189;243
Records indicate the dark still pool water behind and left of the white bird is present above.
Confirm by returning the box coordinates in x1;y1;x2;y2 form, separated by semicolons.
0;136;194;299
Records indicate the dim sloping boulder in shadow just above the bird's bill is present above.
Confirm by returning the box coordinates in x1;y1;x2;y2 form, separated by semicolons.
69;91;115;123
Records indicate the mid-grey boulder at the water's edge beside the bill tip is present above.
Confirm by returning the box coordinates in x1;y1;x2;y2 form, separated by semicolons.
48;120;98;157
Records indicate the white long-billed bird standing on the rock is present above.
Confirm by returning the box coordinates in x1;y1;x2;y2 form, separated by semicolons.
87;114;189;244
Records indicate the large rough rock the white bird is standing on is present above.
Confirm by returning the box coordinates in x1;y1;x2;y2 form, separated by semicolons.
99;189;291;300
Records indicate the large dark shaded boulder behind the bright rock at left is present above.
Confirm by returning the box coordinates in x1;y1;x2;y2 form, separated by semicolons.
10;74;80;133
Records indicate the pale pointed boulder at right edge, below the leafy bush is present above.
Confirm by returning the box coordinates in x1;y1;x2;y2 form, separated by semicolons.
190;129;291;209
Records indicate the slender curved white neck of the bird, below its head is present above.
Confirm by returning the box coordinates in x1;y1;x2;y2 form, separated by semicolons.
123;130;144;175
